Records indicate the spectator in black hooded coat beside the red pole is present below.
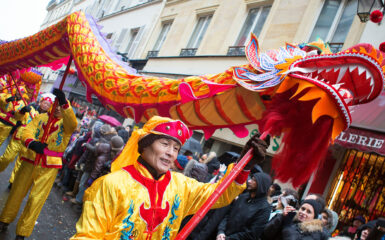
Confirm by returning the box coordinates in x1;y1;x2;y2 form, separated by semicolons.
217;172;271;240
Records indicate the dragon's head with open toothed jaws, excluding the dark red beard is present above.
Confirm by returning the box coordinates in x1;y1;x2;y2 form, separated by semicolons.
234;35;385;139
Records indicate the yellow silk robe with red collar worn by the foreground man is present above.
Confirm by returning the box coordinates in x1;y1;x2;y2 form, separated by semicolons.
71;162;248;240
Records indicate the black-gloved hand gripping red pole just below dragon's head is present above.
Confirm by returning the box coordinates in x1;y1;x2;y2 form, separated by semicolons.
239;134;270;170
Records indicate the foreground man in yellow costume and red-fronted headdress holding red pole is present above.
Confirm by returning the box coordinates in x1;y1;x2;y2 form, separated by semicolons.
71;117;266;240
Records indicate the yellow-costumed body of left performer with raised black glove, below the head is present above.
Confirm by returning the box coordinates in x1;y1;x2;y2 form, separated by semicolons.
0;89;77;240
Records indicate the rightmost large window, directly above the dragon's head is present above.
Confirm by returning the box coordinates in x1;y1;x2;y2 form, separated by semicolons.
309;0;357;50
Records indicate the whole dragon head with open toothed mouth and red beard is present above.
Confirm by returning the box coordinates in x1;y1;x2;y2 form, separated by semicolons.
233;36;385;186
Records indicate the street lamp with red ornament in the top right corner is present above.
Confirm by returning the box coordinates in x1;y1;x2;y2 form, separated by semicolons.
357;0;384;23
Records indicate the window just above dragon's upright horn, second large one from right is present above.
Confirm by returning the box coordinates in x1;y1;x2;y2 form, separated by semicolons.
235;6;271;46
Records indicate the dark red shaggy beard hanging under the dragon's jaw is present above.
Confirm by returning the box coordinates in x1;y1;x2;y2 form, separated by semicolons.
259;88;333;187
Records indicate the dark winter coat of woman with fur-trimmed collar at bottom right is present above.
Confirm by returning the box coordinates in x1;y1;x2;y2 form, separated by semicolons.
261;214;328;240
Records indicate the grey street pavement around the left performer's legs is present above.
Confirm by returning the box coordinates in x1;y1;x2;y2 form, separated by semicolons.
0;137;80;240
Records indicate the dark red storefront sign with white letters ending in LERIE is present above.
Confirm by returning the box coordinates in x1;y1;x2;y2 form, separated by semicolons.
334;128;385;155
